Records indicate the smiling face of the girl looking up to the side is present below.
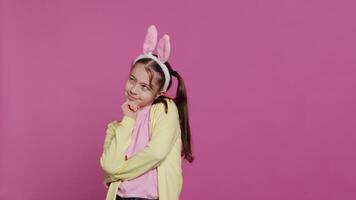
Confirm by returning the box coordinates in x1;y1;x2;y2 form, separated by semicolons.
125;63;160;107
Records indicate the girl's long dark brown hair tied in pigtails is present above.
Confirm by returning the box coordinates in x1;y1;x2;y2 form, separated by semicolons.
131;54;194;163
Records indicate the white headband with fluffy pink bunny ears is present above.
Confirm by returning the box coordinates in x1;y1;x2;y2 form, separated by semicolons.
134;25;171;91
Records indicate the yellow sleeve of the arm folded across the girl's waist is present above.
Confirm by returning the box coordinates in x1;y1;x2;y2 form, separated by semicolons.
104;103;180;181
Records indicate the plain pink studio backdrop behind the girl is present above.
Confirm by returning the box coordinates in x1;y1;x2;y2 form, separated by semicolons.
0;0;356;200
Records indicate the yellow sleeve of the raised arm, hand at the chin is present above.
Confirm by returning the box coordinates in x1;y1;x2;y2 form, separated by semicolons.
100;116;135;178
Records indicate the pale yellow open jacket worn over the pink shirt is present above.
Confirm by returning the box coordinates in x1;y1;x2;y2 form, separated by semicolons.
100;99;183;200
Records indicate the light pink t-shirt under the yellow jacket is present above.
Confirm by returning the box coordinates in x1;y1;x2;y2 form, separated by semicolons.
117;105;158;199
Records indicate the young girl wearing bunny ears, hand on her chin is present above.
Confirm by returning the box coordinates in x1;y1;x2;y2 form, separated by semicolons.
100;25;193;200
